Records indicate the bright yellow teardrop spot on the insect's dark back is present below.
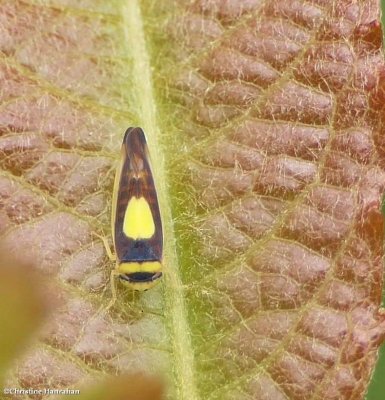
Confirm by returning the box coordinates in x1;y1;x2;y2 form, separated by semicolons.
123;196;155;240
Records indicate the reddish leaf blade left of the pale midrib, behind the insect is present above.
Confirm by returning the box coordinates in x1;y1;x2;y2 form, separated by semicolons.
0;0;168;396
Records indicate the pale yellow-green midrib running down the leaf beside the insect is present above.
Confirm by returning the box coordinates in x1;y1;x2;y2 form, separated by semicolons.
121;0;199;400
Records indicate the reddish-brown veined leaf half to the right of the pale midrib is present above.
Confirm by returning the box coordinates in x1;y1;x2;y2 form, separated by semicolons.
170;0;385;400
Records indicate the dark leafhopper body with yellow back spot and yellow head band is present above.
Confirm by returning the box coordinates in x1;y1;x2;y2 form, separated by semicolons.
112;128;163;290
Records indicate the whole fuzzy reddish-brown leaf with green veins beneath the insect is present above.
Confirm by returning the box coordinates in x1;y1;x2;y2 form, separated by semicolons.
0;0;385;400
